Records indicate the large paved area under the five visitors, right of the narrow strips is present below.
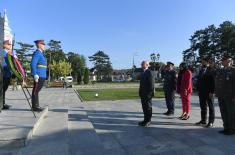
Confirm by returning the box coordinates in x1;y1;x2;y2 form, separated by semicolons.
81;97;235;155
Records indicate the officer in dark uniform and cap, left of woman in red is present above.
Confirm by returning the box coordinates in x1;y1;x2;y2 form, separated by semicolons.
163;62;176;116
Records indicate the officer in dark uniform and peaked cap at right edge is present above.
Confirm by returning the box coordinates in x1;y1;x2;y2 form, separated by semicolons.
215;55;235;135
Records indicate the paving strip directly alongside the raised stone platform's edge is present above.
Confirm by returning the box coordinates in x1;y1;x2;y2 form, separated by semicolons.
17;106;68;155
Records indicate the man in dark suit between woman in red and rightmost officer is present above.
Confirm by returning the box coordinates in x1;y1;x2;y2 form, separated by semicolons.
196;58;215;127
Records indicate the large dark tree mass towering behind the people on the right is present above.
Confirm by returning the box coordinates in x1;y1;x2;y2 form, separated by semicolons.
183;21;235;67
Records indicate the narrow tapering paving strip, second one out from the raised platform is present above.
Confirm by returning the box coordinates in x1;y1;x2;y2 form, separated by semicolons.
68;104;105;155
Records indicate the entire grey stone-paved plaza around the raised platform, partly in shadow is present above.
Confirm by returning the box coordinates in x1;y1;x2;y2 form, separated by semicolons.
0;88;235;155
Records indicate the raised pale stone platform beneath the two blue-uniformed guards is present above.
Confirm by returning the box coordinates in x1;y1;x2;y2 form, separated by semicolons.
0;105;48;150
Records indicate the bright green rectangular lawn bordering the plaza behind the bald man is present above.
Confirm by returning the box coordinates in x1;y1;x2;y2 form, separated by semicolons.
78;88;164;101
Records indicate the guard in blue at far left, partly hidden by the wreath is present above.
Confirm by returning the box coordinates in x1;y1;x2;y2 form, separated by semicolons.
3;40;15;109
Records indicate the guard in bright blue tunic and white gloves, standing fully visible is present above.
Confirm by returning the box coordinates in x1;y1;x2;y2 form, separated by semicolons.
31;40;47;112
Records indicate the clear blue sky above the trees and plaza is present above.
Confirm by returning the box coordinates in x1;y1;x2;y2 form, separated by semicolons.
0;0;235;69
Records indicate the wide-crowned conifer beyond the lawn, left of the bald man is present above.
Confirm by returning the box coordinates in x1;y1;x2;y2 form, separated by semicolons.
88;51;113;80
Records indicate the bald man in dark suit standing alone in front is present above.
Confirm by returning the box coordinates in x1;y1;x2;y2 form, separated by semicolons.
139;61;154;127
